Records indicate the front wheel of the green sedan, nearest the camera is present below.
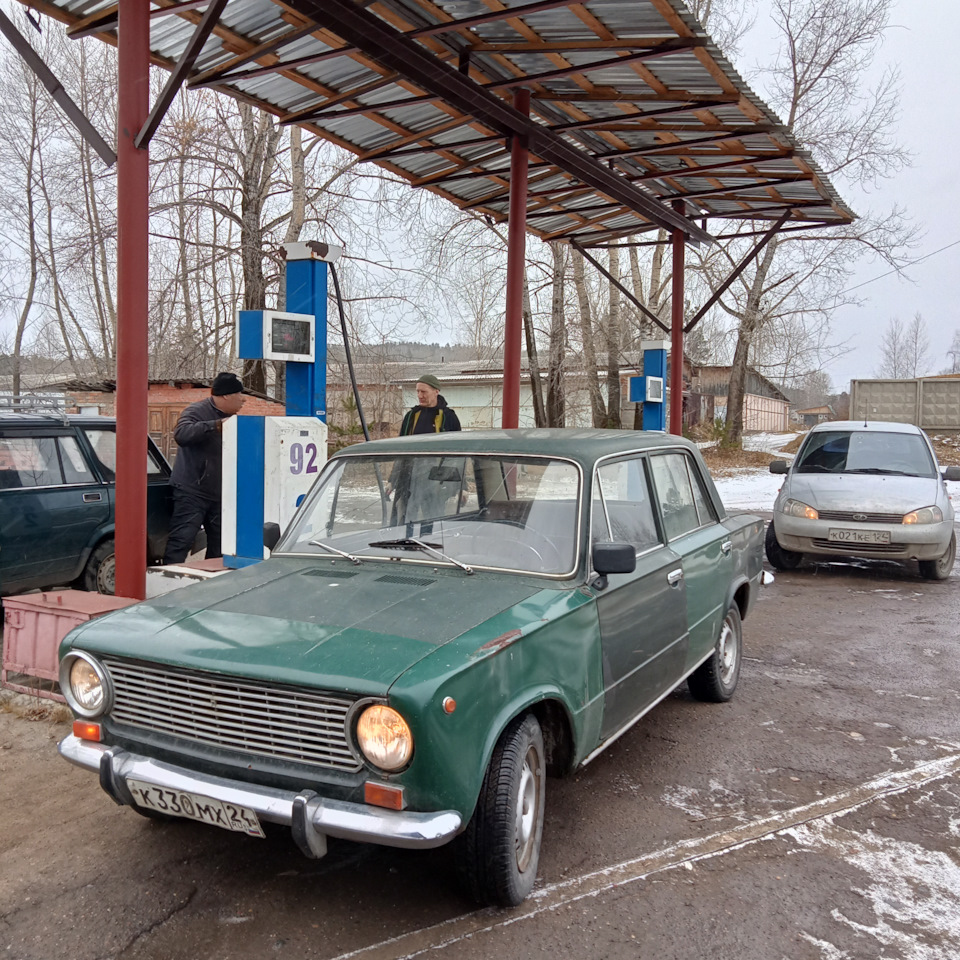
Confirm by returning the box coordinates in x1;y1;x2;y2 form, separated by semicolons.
457;713;546;907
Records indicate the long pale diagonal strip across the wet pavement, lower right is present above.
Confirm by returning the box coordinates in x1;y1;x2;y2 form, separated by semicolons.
334;753;960;960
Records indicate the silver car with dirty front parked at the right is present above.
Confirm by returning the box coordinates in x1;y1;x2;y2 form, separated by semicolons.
766;420;960;580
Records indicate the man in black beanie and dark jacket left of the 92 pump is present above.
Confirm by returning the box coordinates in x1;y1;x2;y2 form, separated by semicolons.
163;373;245;563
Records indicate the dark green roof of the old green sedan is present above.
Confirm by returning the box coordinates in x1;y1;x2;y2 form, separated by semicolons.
331;427;696;465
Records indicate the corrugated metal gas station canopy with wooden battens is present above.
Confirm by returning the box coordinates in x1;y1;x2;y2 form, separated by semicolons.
31;0;854;247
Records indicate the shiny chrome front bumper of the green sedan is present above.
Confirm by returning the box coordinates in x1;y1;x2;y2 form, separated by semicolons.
58;735;462;858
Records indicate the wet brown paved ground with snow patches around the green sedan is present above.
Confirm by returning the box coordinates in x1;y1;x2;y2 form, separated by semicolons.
0;536;960;960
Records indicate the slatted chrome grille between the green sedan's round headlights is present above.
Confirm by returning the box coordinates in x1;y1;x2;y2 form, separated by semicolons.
103;659;361;771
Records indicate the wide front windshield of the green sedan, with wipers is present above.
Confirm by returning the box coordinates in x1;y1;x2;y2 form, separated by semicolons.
275;455;581;576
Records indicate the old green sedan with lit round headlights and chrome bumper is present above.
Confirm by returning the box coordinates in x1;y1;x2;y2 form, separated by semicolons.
60;430;763;905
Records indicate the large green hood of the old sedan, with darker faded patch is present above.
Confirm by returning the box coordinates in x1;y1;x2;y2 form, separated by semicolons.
65;558;542;696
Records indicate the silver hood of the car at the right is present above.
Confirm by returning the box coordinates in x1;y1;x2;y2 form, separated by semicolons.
782;473;944;513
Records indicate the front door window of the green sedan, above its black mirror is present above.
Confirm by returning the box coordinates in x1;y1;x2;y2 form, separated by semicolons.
593;458;660;551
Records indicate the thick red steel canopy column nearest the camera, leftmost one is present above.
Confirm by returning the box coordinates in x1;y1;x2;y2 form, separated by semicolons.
116;0;150;600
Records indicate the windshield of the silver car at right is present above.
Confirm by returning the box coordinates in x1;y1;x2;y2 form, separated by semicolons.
795;430;937;477
